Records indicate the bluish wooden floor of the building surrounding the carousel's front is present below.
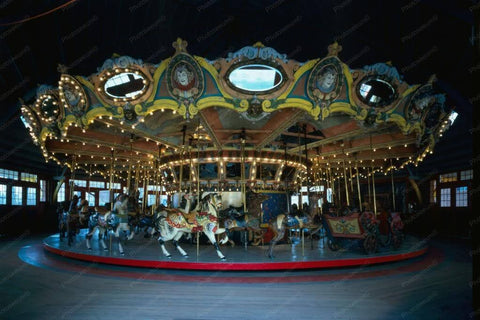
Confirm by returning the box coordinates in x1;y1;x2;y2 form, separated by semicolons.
0;234;472;320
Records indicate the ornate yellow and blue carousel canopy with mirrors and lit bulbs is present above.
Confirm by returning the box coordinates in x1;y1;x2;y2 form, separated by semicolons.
18;39;452;190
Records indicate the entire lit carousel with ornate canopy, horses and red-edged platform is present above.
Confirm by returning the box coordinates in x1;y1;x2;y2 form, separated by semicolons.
21;39;456;270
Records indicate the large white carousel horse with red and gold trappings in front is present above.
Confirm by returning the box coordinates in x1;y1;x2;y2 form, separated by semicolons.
158;193;228;260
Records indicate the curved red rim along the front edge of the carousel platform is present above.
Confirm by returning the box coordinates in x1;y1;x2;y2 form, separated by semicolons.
43;242;428;271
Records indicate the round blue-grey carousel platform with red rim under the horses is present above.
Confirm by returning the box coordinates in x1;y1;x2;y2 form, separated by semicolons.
43;230;428;271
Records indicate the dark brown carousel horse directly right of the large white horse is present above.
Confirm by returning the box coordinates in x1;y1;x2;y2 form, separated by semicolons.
223;191;270;246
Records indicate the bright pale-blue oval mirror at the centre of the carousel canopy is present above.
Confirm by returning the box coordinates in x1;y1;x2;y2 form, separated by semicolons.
228;64;283;92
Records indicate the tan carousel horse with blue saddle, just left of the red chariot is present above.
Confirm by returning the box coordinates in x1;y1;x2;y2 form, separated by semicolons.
268;194;321;259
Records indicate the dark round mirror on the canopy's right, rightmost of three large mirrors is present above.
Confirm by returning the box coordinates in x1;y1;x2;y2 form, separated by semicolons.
359;78;395;106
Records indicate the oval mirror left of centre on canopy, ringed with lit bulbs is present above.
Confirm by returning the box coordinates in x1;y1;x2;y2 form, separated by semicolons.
104;72;145;98
